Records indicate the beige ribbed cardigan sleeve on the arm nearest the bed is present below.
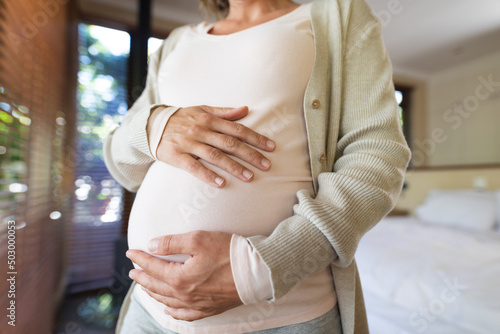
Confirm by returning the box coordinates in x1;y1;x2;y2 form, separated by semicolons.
248;0;410;301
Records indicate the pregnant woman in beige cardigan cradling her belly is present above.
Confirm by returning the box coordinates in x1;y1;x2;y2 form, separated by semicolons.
104;0;410;334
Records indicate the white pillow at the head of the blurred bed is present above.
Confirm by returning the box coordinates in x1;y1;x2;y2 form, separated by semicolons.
415;189;497;230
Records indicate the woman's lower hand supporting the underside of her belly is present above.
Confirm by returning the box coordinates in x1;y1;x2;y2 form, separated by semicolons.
127;231;242;321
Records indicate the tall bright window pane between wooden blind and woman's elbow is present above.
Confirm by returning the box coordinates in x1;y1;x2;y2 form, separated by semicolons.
68;23;130;292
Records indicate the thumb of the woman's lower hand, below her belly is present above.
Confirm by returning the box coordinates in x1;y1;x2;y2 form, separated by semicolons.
146;232;197;256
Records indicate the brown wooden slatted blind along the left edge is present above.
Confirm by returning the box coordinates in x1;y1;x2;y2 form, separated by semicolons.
0;0;75;333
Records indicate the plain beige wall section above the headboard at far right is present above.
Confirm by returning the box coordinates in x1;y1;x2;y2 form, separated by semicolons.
424;52;500;166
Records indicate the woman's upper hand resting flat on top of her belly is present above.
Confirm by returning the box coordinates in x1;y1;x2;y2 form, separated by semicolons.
157;105;276;188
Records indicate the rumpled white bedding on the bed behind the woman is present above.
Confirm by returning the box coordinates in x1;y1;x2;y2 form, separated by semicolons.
356;217;500;334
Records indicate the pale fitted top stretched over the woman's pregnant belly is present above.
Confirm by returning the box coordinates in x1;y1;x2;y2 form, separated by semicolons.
128;3;336;334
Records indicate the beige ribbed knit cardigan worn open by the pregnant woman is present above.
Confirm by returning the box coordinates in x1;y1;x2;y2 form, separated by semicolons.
104;0;410;334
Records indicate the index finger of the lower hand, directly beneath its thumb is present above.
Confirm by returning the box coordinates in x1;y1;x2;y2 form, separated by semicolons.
126;249;182;284
